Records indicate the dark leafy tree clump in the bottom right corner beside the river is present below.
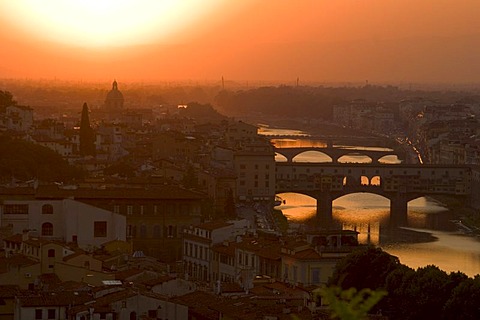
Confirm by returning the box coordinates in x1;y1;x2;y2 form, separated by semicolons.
329;247;480;320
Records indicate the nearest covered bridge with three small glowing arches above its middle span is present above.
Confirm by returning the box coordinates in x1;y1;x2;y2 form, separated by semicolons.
276;162;472;229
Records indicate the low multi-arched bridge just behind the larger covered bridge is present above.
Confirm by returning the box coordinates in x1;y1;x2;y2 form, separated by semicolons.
275;147;404;163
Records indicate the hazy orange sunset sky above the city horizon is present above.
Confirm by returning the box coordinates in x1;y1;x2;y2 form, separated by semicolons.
0;0;480;83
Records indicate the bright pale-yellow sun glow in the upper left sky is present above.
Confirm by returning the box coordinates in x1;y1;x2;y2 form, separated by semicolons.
0;0;218;47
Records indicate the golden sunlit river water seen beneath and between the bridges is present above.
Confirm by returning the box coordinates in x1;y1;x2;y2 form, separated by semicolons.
262;129;480;277
